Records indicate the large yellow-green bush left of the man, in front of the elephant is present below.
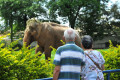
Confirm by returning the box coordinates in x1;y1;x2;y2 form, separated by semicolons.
0;35;54;80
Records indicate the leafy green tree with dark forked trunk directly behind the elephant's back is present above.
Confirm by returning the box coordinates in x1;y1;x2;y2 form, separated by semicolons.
48;0;107;28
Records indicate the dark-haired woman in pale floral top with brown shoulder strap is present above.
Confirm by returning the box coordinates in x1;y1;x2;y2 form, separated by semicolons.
81;35;105;80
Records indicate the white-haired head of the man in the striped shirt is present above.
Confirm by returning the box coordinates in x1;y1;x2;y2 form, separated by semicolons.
63;28;76;41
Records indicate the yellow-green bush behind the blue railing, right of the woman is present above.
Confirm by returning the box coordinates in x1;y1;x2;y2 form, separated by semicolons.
101;41;120;80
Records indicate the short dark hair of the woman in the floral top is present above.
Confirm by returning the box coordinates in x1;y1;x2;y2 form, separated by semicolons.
82;35;93;49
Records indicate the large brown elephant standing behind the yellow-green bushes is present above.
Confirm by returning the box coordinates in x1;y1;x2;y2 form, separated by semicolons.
23;18;81;60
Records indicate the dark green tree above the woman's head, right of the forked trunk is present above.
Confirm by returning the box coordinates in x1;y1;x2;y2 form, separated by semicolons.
76;1;106;40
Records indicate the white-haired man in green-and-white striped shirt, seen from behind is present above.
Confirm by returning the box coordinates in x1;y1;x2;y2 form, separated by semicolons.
53;28;85;80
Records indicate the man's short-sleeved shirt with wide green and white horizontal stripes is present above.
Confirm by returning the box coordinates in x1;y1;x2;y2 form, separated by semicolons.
53;42;85;80
